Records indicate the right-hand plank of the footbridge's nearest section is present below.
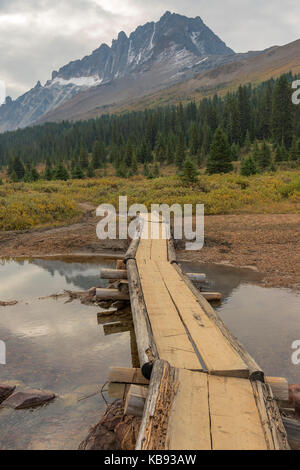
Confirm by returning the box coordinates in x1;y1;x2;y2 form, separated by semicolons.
208;376;268;450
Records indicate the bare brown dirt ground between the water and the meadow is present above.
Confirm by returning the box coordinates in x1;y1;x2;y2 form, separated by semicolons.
0;212;300;289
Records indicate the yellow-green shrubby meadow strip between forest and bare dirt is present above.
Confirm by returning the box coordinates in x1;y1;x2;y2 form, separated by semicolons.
0;169;300;231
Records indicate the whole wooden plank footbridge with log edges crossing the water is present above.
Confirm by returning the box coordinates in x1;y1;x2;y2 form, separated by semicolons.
102;215;289;450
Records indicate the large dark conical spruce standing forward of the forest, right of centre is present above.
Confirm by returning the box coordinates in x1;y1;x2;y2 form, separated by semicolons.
207;127;233;175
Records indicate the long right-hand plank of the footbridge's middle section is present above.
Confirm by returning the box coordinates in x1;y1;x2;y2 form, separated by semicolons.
157;263;249;377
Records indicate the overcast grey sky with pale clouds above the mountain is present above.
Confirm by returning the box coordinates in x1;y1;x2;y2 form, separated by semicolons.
0;0;300;98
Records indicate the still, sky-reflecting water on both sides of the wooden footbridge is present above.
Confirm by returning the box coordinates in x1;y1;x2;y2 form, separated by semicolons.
0;259;300;449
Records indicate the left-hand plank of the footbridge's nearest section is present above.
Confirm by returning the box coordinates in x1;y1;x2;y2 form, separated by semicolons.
166;369;211;450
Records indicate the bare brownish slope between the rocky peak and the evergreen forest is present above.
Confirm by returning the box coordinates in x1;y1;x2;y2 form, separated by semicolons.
41;40;300;122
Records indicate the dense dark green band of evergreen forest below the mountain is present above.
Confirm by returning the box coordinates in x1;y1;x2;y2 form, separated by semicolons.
0;73;300;181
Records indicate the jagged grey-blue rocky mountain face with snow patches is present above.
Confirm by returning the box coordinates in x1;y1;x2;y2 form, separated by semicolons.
0;12;235;132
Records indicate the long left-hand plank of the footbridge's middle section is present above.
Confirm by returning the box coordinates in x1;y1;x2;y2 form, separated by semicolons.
139;260;202;370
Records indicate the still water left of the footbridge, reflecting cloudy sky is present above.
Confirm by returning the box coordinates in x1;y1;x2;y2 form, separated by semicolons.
0;260;132;449
